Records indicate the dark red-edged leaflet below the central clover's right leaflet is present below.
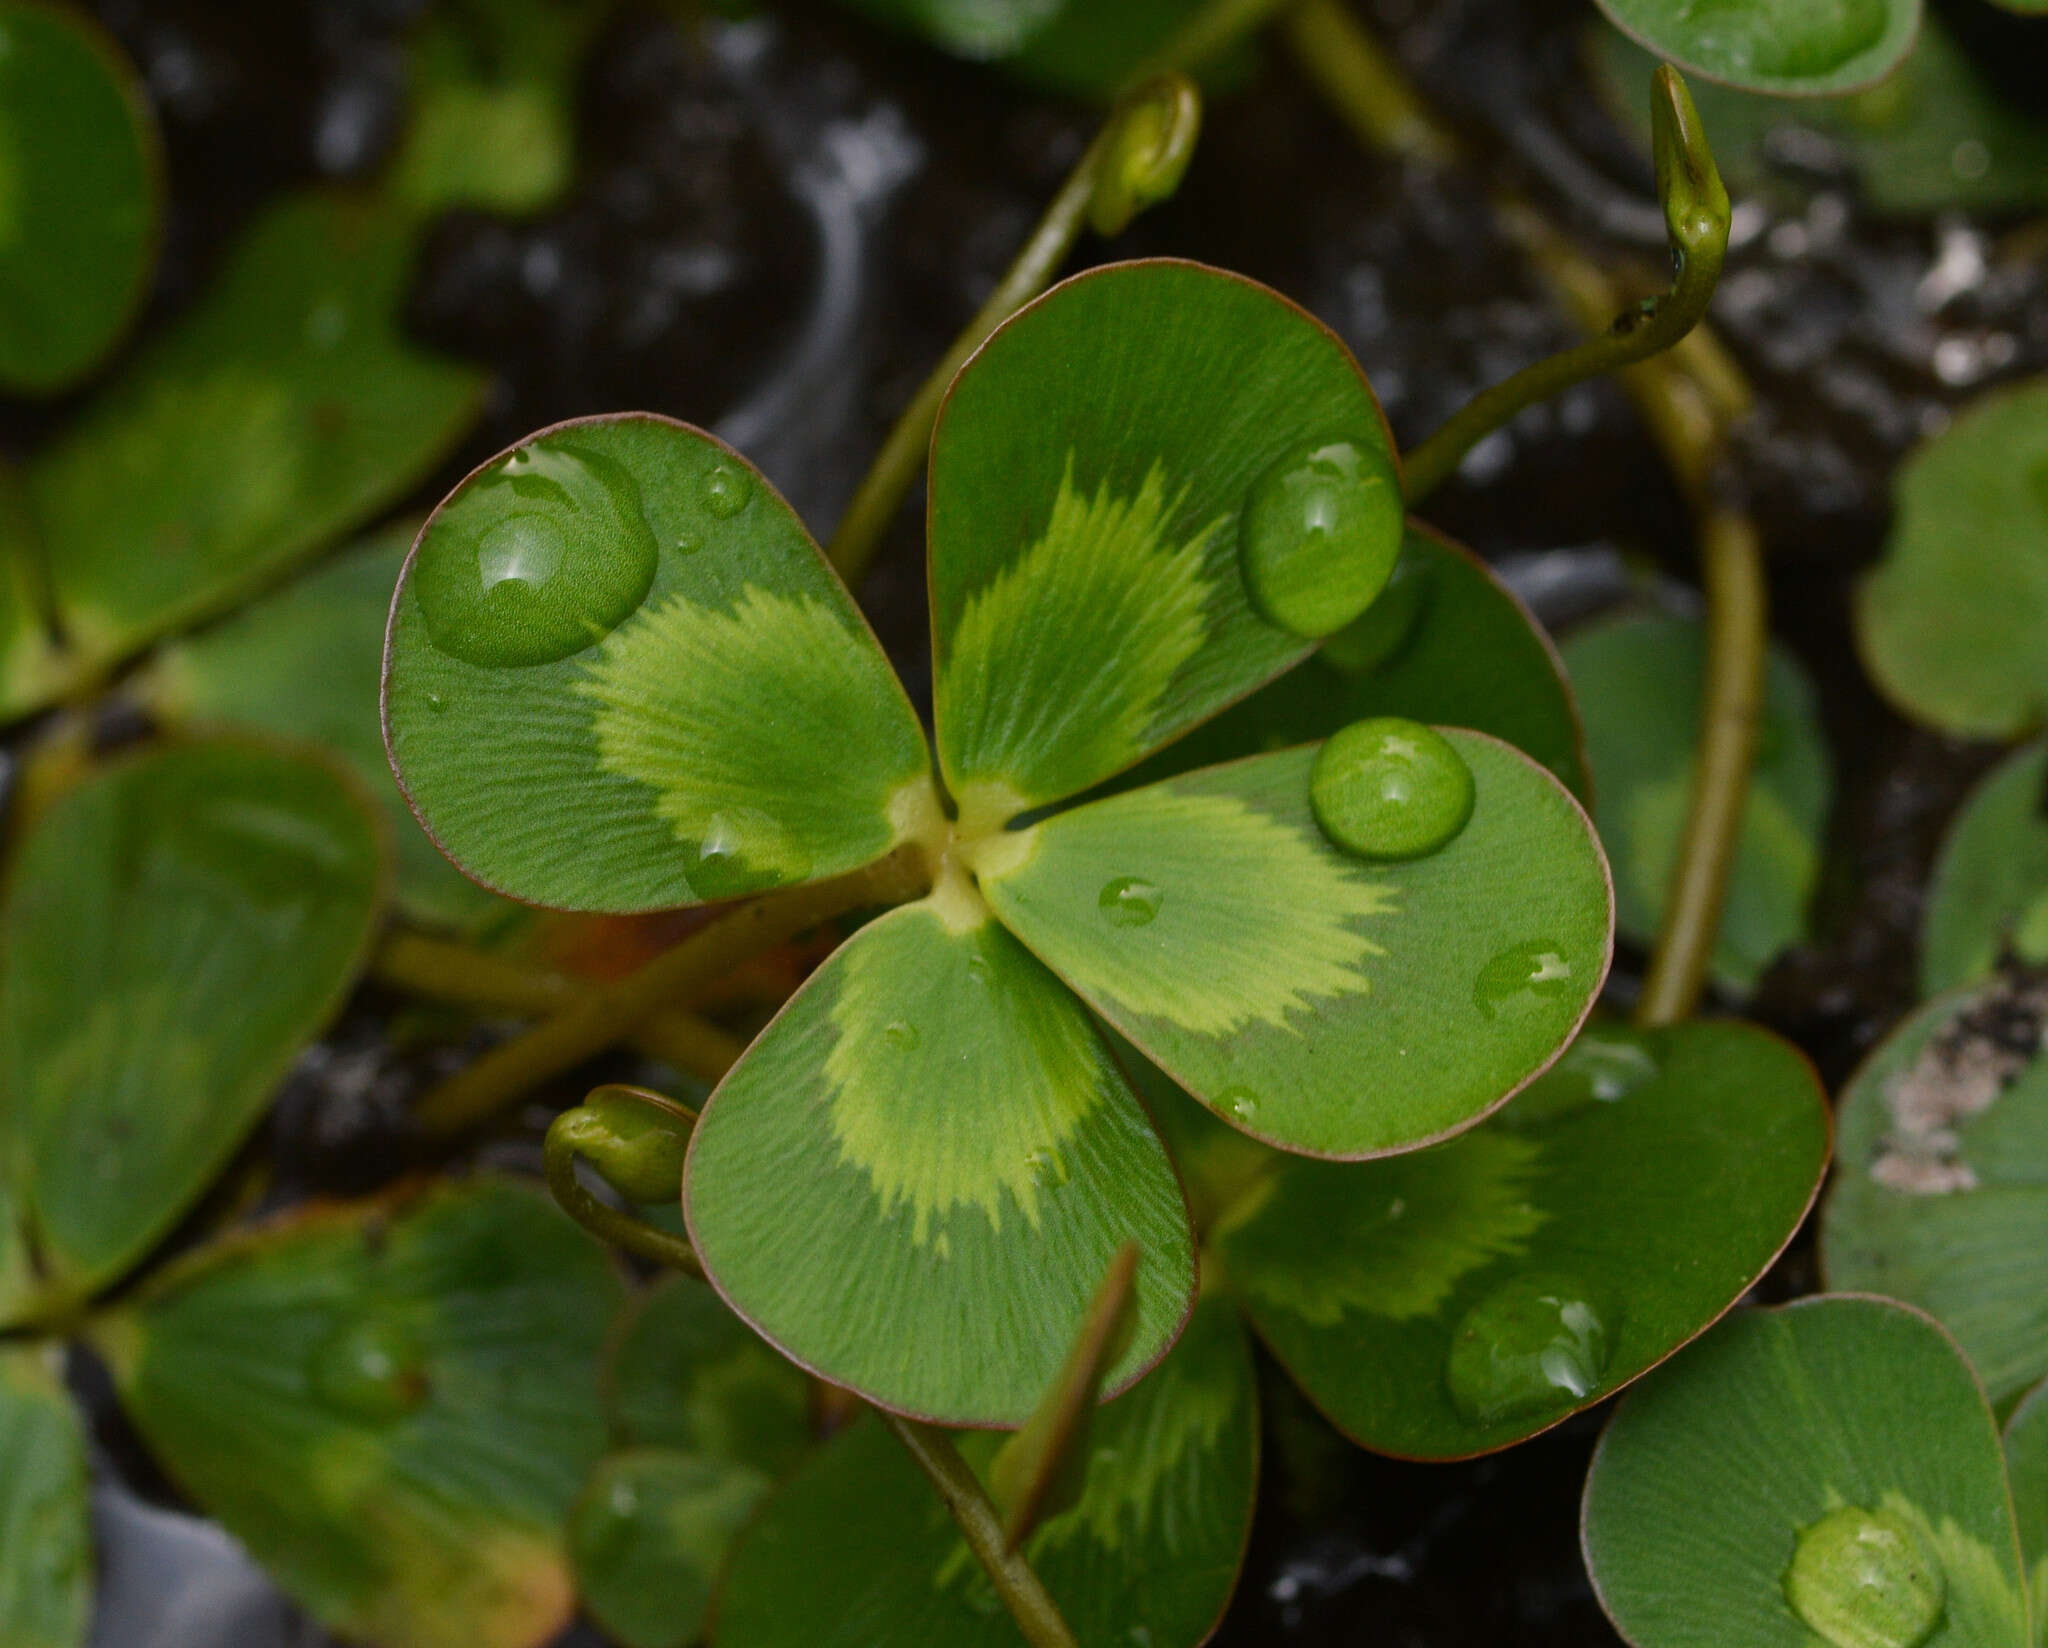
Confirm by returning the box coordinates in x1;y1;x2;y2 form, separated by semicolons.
1196;1024;1829;1460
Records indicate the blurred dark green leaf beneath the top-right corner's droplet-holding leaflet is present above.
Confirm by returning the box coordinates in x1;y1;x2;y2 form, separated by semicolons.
1591;16;2048;217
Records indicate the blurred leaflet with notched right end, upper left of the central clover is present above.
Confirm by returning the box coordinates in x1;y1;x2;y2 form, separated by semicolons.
14;194;483;708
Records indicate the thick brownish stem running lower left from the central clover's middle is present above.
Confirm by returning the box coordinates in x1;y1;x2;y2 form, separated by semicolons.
414;845;930;1136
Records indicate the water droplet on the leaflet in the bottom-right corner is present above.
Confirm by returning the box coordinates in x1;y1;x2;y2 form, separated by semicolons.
1784;1505;1948;1648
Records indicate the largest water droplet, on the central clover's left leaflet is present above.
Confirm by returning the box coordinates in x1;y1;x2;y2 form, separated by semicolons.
412;434;657;667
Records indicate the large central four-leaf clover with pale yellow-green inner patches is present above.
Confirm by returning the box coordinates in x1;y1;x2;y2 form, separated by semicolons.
385;262;1612;1425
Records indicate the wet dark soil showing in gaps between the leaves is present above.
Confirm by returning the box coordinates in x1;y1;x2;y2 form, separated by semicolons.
16;0;2048;1648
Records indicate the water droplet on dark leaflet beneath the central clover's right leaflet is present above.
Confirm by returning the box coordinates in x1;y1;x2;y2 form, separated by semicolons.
1444;1273;1612;1425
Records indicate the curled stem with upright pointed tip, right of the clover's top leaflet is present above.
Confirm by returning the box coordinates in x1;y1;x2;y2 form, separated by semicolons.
1403;63;1731;504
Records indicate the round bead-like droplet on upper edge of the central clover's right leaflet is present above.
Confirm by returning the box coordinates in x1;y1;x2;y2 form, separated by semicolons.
1309;714;1475;858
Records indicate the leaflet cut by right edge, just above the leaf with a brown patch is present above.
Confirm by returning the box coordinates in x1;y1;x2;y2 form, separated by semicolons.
1919;743;2048;995
